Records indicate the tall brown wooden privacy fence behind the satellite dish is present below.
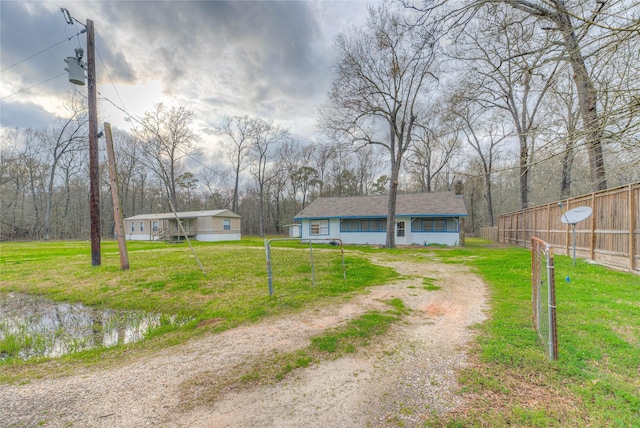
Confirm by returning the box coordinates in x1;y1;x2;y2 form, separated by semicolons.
498;182;640;273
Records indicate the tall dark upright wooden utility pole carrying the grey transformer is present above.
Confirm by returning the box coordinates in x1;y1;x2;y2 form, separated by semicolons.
87;19;101;266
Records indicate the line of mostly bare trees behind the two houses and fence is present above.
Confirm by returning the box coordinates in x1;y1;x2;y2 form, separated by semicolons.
0;0;640;246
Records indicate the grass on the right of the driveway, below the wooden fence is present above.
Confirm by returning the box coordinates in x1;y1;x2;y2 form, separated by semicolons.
427;240;640;427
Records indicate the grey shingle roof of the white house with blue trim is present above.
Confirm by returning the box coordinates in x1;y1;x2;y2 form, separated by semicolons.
295;192;467;220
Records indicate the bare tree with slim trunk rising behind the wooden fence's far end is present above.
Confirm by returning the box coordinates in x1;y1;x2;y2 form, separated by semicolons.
454;4;558;208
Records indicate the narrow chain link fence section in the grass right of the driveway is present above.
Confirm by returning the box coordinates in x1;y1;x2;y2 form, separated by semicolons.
531;237;558;360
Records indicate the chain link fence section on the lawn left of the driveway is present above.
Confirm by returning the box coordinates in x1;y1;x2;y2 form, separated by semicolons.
264;238;347;296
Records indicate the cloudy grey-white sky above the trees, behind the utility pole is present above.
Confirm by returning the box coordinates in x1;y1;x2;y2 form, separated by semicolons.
0;0;376;144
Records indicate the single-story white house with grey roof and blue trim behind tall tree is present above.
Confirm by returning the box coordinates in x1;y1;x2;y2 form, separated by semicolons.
294;192;467;246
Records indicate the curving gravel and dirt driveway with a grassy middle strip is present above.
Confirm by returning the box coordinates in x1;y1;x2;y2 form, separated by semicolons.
0;254;487;428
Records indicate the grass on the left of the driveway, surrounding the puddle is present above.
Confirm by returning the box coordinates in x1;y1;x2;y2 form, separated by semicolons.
0;239;397;381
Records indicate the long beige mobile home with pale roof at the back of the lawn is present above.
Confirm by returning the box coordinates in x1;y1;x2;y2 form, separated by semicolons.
124;210;240;242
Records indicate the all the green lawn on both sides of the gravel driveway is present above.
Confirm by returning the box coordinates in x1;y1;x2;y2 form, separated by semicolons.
0;239;640;427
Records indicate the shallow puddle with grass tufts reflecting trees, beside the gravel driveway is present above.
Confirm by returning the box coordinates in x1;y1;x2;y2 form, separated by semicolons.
0;293;184;361
